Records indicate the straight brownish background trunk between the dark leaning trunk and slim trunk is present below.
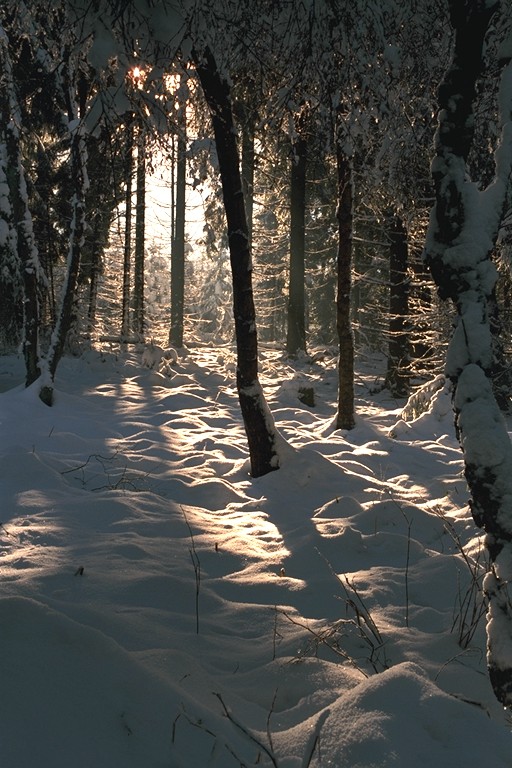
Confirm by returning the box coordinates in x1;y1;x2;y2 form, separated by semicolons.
286;136;307;357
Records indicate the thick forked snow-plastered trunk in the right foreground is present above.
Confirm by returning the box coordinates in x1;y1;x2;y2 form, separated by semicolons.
426;0;512;706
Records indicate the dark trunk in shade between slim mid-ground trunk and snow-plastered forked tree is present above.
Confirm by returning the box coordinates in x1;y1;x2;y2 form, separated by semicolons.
385;214;410;397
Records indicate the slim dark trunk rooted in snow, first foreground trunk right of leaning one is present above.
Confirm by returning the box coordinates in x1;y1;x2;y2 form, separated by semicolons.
336;150;355;429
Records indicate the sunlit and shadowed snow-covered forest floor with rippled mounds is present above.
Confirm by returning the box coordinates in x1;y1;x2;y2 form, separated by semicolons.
0;347;512;768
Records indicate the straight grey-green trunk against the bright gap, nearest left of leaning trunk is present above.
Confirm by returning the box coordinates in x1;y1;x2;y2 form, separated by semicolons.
169;93;187;348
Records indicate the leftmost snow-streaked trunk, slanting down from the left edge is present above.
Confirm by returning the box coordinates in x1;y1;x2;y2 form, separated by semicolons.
0;25;44;386
